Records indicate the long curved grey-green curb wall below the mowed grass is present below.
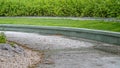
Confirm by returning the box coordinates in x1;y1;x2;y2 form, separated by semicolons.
0;24;120;45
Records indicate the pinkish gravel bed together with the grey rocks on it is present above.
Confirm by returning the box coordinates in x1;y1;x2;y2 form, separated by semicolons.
0;36;42;68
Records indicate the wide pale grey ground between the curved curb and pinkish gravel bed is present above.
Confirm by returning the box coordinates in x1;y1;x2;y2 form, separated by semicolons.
5;32;120;68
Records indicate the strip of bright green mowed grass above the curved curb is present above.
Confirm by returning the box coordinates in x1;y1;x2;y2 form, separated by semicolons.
0;18;120;32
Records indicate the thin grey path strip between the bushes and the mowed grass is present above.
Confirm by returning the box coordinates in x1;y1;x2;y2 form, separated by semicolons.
0;16;120;22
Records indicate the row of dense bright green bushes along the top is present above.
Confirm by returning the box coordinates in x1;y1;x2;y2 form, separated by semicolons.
0;0;120;18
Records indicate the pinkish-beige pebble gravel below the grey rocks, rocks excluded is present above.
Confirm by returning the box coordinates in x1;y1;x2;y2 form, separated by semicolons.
0;49;41;68
